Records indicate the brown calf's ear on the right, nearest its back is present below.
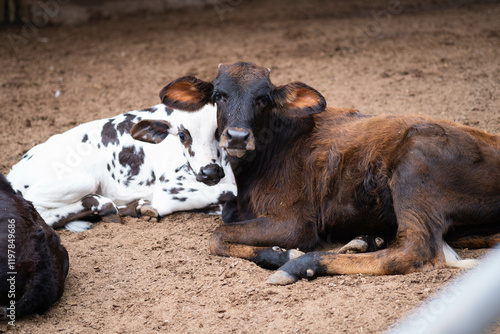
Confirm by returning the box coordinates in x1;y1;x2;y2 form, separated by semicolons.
273;82;326;118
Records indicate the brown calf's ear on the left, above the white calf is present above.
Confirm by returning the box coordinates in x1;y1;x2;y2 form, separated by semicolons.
160;76;213;111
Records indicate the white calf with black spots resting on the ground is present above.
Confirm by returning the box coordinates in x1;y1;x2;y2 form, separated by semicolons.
7;101;236;231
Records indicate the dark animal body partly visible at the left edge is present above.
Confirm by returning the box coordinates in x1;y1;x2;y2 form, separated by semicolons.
0;174;69;321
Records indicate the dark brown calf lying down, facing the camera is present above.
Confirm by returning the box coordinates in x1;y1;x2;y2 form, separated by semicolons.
158;62;500;284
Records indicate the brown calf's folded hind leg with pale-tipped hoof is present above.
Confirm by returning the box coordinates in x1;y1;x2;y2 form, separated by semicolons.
268;198;452;285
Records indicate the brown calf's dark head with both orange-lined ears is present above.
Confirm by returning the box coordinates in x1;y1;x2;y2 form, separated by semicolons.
158;62;326;158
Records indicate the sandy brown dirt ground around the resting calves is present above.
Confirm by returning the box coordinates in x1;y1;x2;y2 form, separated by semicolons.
0;0;500;333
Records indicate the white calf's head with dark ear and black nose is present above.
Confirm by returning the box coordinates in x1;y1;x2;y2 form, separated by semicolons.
130;102;225;185
